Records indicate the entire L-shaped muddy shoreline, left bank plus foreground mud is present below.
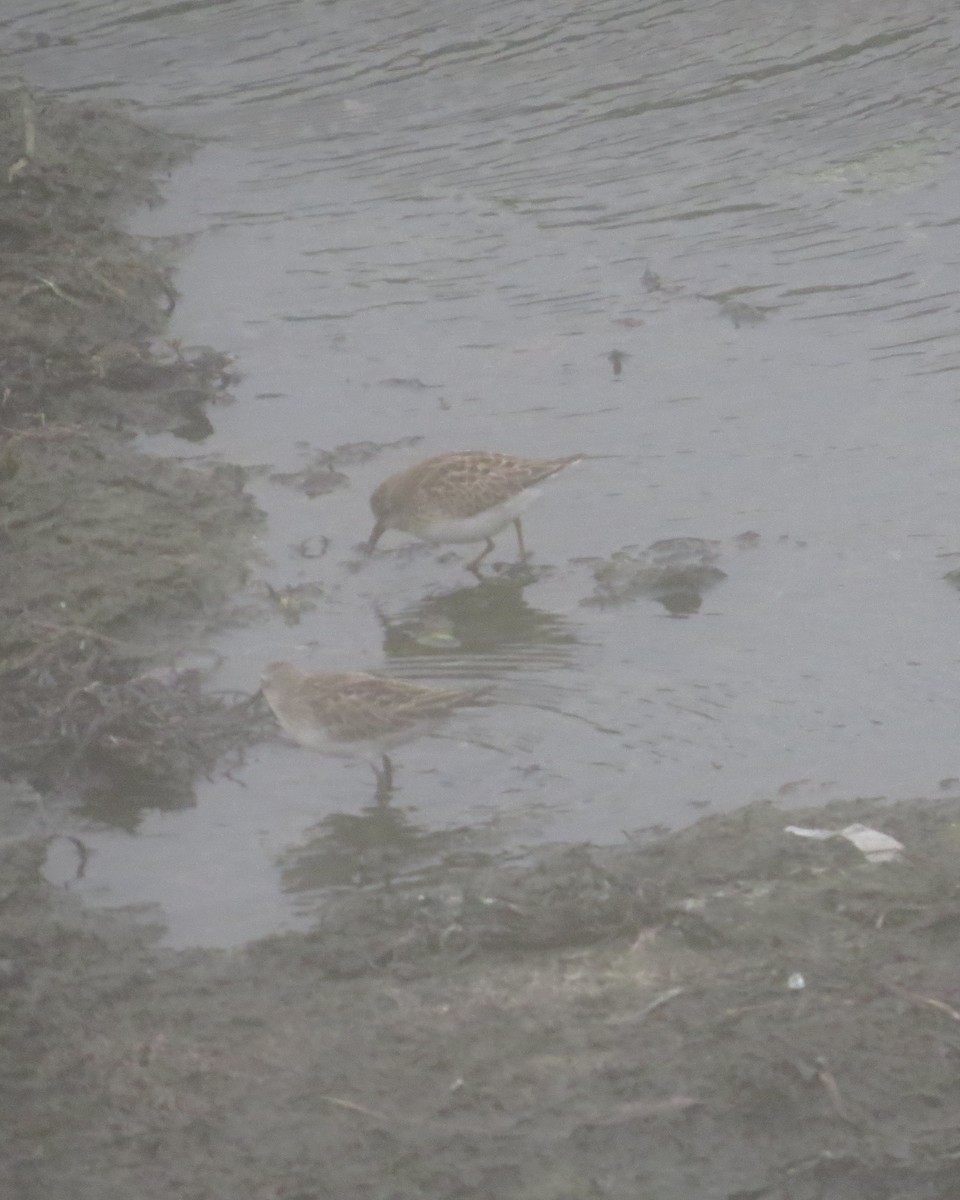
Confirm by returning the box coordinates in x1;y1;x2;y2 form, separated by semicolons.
0;85;960;1200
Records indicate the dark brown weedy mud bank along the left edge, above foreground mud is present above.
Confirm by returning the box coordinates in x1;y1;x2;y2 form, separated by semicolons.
0;83;260;804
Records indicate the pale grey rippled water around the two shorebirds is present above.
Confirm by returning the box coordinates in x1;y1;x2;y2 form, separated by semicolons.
11;0;960;944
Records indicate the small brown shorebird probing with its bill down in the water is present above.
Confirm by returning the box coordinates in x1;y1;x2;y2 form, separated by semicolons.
367;450;583;577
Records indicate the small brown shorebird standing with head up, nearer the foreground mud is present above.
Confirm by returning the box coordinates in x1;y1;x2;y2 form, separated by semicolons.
260;662;488;792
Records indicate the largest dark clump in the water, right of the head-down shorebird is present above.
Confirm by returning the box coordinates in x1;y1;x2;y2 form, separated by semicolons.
583;538;726;617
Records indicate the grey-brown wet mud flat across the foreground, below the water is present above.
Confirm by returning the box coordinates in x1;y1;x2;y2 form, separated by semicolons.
0;798;960;1200
